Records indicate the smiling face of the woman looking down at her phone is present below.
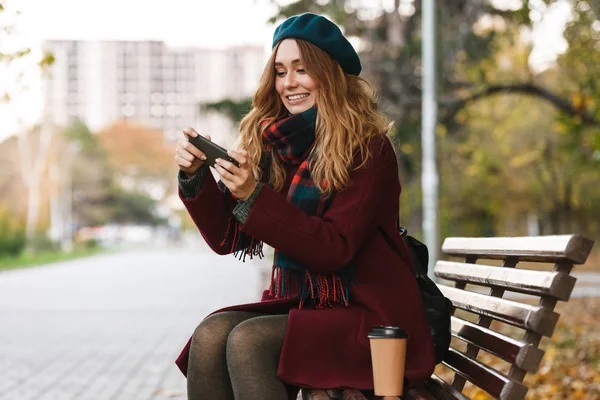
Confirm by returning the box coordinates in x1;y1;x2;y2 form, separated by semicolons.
275;39;319;114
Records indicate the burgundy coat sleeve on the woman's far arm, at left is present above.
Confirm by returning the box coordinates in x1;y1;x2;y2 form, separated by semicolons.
179;168;235;255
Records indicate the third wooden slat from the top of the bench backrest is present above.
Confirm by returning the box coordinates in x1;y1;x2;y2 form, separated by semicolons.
438;285;558;337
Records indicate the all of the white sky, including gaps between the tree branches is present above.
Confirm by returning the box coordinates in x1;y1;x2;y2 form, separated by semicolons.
0;0;568;140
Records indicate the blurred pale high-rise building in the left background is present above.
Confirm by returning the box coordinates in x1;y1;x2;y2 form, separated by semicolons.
44;40;266;145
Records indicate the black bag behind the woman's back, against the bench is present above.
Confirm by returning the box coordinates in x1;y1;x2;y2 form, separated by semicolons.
382;222;452;364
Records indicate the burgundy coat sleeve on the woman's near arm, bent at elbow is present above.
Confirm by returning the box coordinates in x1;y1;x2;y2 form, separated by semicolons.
241;138;400;274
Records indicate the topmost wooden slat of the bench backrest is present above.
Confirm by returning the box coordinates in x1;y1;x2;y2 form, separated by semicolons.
442;235;594;264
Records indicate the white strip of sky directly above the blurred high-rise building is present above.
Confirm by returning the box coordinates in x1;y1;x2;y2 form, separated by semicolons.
5;0;274;47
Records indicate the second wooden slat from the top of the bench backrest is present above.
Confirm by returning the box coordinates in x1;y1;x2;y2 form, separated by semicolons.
435;261;577;300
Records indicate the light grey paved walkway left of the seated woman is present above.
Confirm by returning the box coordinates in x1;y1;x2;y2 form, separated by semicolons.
0;249;262;400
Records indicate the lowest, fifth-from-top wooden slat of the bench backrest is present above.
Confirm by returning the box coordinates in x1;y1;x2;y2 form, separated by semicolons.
444;348;527;400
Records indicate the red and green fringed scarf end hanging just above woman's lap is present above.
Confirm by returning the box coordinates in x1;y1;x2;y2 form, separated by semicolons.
269;266;354;308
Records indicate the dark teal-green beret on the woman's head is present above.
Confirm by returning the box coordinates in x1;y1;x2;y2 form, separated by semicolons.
273;13;361;75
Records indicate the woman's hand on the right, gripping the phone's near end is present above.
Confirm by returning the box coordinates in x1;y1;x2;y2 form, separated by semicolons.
215;150;256;200
